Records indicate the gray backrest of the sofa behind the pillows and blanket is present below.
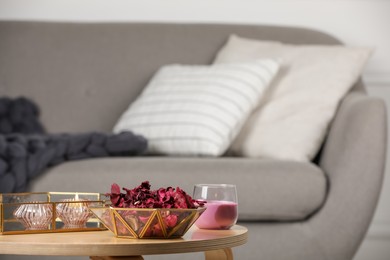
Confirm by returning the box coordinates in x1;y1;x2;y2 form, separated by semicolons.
0;21;341;133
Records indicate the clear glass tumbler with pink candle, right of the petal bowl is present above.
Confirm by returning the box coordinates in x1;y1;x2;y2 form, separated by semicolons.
193;184;238;229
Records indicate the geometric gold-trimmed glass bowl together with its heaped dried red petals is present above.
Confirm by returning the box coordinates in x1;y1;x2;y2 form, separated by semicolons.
90;181;206;238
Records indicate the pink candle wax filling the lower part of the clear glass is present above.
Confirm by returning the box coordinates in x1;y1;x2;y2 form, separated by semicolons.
195;200;238;229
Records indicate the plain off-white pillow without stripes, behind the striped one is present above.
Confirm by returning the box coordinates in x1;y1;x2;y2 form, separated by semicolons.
214;35;372;161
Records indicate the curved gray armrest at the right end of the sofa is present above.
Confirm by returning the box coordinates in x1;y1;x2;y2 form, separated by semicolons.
310;91;387;259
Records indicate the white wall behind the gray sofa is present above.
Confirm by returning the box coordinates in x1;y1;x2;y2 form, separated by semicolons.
0;0;390;260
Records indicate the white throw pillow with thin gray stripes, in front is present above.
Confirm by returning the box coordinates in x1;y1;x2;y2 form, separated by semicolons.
114;59;279;156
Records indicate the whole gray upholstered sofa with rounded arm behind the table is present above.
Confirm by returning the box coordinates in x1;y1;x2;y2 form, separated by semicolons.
0;22;386;260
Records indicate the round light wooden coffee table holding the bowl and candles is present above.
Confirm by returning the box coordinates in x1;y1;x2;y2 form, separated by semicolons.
0;225;248;260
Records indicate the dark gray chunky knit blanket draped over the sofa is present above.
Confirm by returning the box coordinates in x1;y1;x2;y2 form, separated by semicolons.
0;98;147;193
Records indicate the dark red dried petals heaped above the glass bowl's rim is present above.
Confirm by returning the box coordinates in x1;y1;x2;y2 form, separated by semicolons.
106;181;205;209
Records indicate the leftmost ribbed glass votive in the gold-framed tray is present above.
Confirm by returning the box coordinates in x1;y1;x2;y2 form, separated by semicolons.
13;203;53;230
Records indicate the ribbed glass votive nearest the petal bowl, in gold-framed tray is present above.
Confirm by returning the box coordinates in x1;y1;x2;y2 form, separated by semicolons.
56;198;92;228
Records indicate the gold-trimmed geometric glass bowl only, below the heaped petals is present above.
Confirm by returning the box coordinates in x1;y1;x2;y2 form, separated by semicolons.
90;206;206;238
